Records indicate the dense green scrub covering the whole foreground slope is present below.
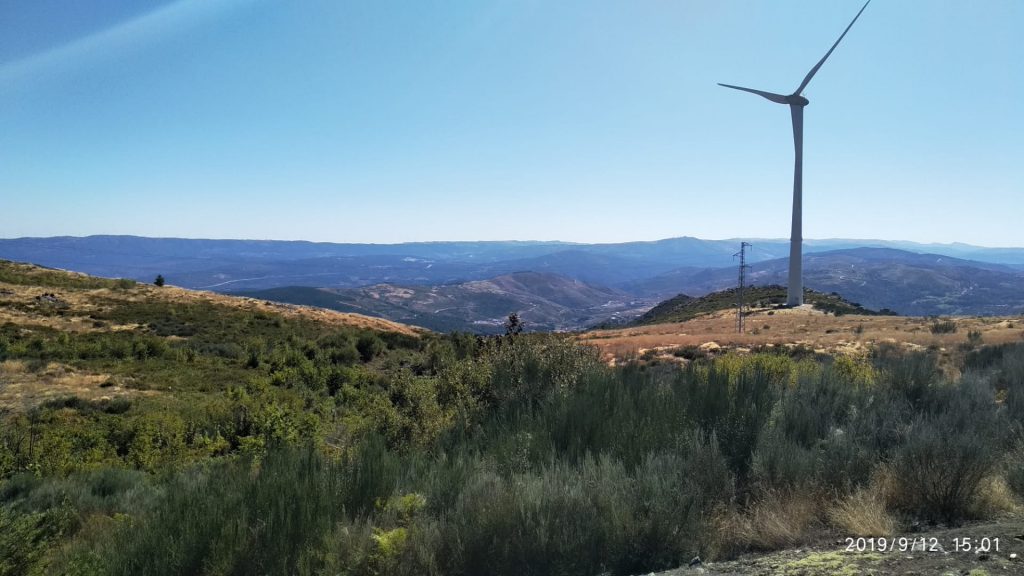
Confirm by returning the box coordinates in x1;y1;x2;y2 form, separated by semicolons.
0;262;1024;575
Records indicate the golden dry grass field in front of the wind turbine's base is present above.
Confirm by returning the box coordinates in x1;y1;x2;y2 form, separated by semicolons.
579;305;1024;362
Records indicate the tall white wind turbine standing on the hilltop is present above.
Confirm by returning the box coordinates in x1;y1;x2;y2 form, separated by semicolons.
719;0;871;306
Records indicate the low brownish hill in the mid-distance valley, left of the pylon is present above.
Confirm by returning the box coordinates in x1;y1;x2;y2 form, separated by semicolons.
235;272;649;334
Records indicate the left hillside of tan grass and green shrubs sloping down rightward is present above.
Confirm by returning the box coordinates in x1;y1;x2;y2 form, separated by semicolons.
0;260;425;410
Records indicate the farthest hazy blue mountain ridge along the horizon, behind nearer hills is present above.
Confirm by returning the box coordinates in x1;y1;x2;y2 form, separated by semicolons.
0;236;1024;289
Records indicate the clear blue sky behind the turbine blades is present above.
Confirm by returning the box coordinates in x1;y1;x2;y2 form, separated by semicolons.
0;0;1024;246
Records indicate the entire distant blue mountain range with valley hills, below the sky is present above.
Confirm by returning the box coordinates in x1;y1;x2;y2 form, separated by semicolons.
0;231;1024;323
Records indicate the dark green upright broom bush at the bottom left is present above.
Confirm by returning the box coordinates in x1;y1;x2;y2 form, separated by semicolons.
89;450;345;575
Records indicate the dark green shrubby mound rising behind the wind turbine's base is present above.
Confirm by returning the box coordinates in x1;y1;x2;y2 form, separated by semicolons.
631;285;893;326
